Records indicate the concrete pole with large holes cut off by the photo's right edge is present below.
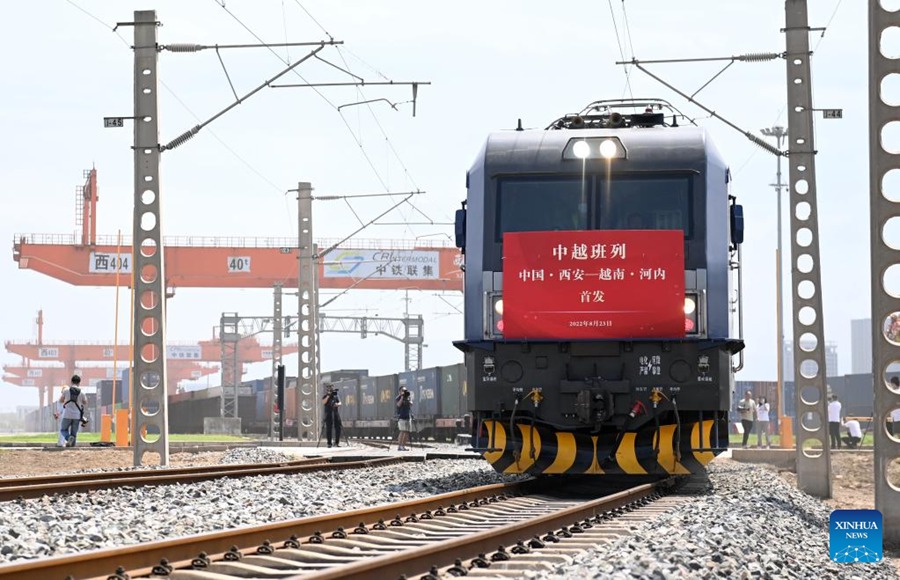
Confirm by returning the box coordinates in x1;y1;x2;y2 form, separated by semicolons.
869;0;900;544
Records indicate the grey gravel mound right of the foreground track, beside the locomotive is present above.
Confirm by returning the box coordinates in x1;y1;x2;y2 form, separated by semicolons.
527;462;897;580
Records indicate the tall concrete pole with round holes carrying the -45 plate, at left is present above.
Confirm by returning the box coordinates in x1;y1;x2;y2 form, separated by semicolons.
131;10;169;466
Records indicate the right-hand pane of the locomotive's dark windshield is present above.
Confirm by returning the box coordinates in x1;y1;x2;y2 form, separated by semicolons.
597;176;691;238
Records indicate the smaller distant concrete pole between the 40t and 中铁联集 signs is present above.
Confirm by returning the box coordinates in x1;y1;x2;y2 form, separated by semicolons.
297;182;320;441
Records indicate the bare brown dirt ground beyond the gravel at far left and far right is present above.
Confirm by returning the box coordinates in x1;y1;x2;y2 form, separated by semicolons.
0;449;900;578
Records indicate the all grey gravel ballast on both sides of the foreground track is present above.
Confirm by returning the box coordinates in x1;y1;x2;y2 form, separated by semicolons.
0;448;897;580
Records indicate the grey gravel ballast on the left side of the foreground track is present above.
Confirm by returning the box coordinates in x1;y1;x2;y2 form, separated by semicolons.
0;448;518;563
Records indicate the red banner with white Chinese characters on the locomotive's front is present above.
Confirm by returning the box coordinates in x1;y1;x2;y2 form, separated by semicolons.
503;230;684;340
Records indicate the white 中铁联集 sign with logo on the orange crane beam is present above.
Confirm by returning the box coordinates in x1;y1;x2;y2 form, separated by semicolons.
323;249;441;280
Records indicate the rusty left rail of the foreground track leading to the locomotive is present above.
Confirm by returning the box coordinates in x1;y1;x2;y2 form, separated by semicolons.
0;480;531;580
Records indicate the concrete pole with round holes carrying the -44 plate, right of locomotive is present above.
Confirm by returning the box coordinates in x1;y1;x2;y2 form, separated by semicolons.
784;0;831;498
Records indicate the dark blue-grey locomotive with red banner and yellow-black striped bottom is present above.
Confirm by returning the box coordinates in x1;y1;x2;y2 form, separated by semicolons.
454;99;744;481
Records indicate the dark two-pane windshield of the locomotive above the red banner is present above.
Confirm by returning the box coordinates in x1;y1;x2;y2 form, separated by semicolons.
496;175;691;242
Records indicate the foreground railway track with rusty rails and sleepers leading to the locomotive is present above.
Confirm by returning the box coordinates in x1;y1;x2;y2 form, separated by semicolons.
0;480;704;580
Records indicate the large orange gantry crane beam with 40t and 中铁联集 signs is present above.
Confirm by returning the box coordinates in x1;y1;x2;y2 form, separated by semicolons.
13;169;463;292
